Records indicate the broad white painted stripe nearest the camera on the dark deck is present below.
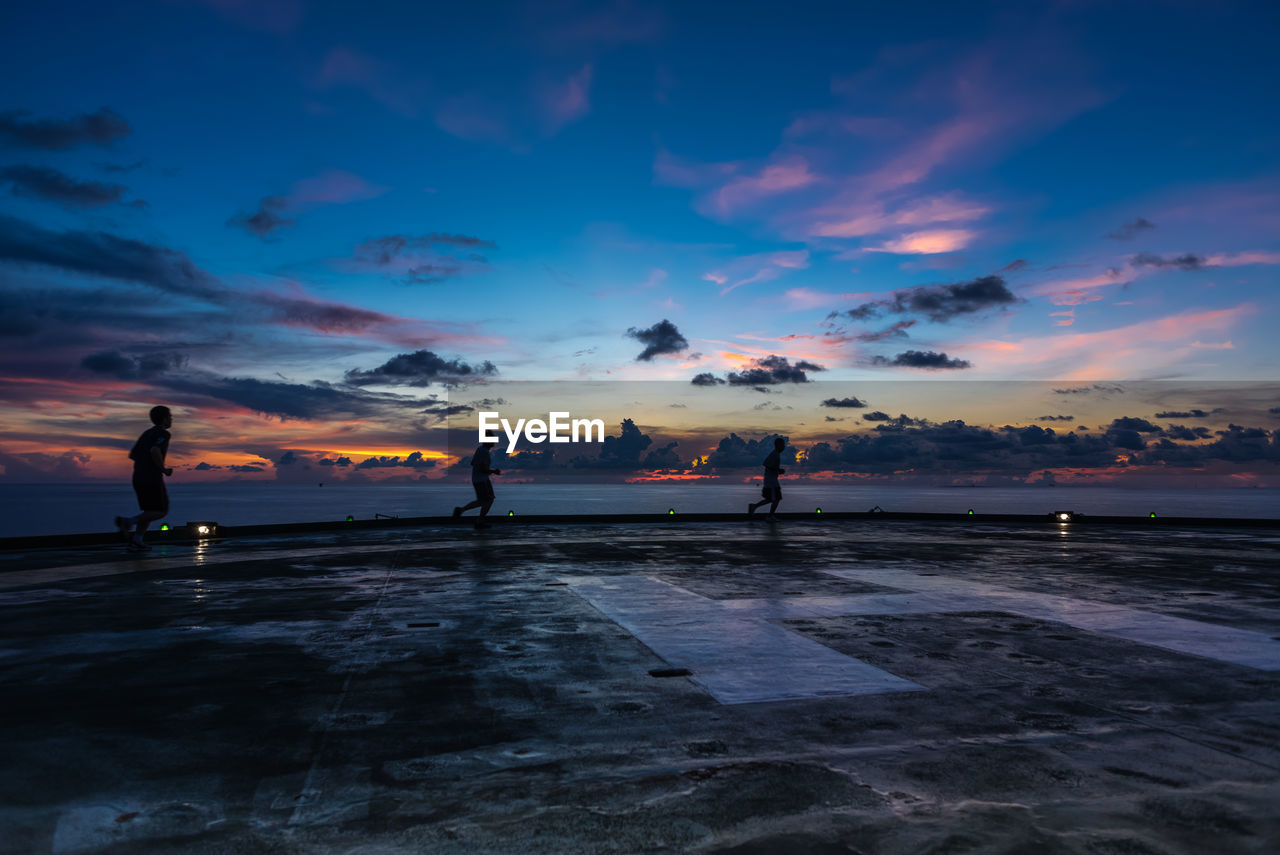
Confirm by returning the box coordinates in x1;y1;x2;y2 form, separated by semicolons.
570;576;924;704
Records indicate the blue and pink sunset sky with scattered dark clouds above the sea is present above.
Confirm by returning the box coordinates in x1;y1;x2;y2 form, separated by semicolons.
0;0;1280;486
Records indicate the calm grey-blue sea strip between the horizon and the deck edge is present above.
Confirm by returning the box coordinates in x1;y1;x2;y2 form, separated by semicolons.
0;480;1280;538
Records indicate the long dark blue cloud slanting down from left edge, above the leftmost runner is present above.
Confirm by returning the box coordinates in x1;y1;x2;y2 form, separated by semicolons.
0;215;228;301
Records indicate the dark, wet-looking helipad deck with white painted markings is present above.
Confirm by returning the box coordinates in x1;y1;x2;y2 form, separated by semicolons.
0;520;1280;855
